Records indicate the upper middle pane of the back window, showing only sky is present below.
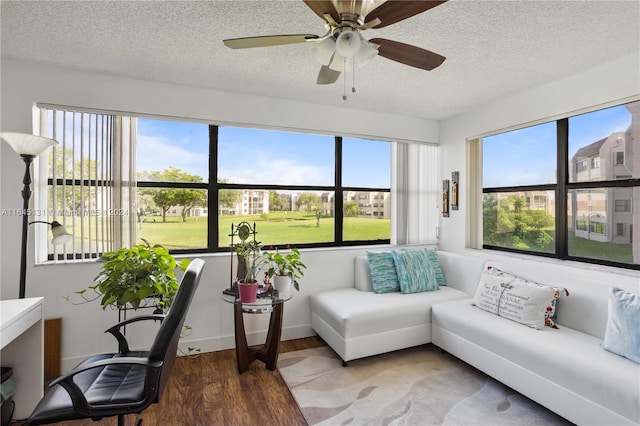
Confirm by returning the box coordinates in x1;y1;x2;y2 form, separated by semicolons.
218;127;335;186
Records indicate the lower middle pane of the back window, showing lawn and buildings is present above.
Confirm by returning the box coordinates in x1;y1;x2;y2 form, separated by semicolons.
218;189;335;247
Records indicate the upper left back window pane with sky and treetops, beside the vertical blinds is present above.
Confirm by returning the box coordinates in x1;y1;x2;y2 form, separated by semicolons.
136;118;209;182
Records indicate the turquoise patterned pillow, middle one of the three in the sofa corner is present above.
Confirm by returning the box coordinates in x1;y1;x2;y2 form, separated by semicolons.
391;250;438;293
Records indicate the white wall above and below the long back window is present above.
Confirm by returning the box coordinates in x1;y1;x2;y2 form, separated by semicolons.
0;58;438;370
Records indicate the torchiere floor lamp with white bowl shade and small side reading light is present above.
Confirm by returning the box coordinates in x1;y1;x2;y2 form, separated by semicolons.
0;132;72;299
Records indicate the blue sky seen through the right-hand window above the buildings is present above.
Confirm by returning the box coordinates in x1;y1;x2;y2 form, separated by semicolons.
482;105;631;187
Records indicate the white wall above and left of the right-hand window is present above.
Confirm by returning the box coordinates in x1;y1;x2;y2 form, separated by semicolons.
439;53;640;252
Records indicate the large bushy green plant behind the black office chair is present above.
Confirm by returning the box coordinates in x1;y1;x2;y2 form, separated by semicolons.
67;240;190;310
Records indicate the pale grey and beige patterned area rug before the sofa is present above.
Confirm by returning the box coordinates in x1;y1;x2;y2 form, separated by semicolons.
278;345;571;426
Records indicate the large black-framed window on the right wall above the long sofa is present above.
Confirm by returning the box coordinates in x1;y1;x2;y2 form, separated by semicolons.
482;102;640;269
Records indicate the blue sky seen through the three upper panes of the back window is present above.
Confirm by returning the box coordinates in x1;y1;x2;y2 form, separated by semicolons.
136;118;391;188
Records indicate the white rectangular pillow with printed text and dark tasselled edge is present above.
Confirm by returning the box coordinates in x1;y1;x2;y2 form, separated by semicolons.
473;266;563;329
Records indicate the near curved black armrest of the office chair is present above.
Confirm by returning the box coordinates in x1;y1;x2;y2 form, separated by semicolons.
49;357;163;416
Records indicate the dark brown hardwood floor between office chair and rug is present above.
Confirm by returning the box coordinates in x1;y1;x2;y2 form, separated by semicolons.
12;337;326;426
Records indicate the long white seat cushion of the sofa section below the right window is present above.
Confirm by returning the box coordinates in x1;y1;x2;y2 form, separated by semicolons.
432;299;640;420
